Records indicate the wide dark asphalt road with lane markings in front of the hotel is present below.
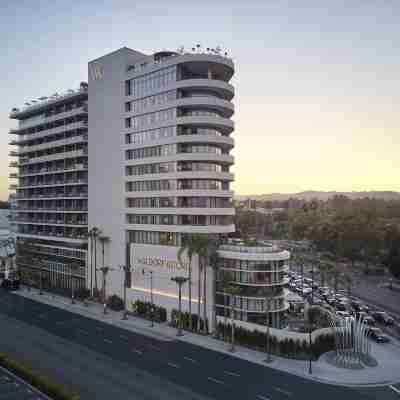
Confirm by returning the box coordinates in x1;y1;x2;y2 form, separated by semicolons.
0;291;399;400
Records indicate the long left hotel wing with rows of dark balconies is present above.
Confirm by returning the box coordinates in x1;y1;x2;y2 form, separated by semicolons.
10;87;88;288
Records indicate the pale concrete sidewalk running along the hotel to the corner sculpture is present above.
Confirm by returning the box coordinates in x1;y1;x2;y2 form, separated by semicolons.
15;289;400;386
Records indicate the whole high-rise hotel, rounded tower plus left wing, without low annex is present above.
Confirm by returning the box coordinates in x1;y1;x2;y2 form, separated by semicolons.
11;47;288;332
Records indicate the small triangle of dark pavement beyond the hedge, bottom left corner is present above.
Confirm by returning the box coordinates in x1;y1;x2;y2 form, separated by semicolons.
0;367;49;400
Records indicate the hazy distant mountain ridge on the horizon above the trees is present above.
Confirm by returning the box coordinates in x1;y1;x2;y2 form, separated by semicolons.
235;190;400;201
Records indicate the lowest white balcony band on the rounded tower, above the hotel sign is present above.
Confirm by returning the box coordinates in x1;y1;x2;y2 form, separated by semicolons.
125;223;235;234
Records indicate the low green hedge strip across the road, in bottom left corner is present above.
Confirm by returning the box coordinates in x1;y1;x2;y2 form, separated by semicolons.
0;353;80;400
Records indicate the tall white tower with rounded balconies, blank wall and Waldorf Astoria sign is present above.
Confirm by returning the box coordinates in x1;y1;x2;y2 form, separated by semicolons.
87;48;234;330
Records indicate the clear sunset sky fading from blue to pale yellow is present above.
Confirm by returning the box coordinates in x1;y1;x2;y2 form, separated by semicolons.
0;0;400;199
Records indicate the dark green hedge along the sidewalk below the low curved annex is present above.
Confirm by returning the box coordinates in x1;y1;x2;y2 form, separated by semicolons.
217;322;335;360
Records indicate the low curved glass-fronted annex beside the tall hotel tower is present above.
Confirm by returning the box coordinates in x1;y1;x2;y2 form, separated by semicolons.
216;244;290;328
